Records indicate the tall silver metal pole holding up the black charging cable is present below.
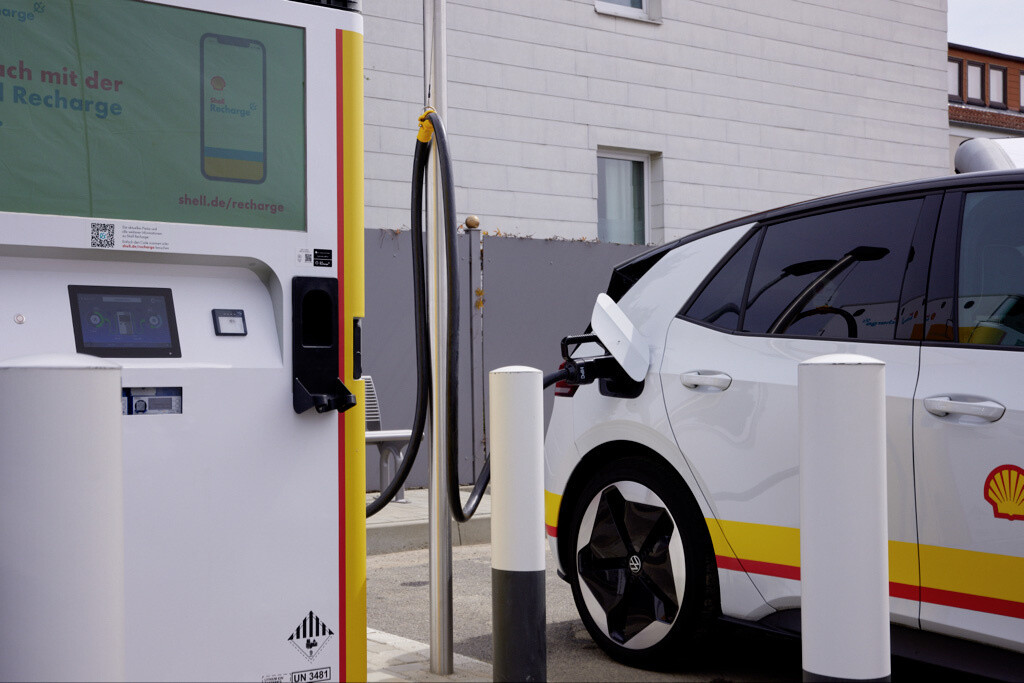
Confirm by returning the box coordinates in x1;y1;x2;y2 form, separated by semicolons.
423;0;454;676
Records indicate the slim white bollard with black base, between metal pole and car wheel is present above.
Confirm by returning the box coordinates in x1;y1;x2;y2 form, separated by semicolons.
488;366;548;681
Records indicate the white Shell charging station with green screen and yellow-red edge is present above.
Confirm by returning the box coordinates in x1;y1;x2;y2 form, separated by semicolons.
0;0;366;681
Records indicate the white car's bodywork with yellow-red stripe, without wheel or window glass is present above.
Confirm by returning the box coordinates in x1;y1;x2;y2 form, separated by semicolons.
545;170;1024;663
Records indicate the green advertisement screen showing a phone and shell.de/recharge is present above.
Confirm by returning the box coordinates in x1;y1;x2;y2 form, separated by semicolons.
0;0;306;230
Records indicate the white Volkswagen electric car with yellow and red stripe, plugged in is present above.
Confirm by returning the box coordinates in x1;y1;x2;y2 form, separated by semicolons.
545;171;1024;667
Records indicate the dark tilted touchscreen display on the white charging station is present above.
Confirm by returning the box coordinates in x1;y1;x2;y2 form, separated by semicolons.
68;285;181;358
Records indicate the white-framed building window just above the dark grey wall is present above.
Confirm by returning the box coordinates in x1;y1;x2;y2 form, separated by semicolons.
597;151;650;245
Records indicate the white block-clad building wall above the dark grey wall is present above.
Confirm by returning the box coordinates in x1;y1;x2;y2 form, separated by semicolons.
362;0;948;243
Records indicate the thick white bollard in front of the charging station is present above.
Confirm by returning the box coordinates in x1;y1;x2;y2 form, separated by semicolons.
0;355;125;681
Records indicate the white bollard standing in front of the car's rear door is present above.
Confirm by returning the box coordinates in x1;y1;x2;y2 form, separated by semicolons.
798;353;892;681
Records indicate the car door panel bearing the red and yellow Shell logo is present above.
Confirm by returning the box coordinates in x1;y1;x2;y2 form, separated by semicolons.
914;347;1024;651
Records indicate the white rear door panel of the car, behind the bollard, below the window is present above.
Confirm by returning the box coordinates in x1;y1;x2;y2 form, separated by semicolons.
662;319;920;626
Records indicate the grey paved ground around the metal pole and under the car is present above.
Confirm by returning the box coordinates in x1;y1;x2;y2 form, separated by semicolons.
367;489;978;681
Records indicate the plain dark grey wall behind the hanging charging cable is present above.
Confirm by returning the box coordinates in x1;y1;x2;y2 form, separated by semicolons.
362;230;645;490
